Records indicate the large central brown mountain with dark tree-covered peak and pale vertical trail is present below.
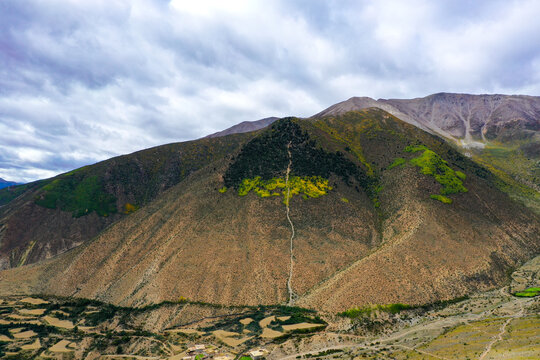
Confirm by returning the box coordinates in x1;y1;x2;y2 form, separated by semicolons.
0;108;540;313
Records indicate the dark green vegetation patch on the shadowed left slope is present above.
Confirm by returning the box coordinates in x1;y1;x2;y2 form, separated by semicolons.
35;174;117;217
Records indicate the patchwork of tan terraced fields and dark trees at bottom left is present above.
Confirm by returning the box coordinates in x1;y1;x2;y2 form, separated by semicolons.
0;296;326;360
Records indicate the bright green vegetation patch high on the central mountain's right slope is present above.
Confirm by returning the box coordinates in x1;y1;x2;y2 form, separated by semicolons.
405;145;468;204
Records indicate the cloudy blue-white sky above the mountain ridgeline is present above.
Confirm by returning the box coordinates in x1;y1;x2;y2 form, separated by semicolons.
0;0;540;181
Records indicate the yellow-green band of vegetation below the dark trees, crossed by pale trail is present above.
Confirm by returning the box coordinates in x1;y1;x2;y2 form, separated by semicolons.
238;176;332;205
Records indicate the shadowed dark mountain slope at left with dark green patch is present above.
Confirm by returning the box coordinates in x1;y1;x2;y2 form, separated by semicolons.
0;134;252;269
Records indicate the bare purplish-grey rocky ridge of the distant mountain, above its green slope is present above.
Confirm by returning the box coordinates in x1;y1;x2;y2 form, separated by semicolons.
314;93;540;141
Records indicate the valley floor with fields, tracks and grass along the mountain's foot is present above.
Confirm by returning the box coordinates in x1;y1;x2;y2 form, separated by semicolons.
0;257;540;360
